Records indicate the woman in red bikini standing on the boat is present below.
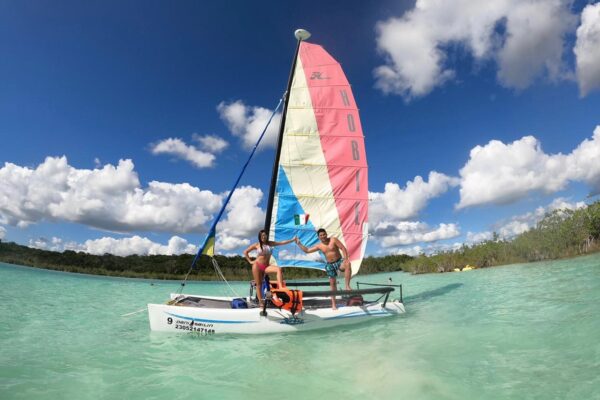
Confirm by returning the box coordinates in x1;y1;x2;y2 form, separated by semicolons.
244;229;296;304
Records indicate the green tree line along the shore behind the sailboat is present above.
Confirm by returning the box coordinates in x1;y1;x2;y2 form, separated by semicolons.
0;201;600;280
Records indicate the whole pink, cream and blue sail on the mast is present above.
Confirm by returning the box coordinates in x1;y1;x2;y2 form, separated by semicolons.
269;42;368;274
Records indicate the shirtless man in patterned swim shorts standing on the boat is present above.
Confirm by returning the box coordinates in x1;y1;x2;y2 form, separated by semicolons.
296;228;352;310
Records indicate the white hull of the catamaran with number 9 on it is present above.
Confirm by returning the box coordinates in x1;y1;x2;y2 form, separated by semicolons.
148;295;404;335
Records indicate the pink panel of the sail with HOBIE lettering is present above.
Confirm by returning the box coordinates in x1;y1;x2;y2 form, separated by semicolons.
299;42;369;269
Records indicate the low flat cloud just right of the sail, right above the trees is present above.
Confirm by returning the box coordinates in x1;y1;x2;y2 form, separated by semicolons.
372;221;460;247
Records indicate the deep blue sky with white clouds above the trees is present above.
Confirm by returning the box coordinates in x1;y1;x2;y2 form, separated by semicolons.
0;0;600;256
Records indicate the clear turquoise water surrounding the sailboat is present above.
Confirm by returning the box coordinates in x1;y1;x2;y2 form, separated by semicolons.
0;255;600;400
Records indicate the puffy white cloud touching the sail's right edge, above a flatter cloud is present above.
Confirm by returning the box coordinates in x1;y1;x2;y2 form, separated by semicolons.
369;171;459;225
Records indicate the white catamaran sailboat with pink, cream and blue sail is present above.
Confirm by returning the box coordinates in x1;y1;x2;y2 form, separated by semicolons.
148;29;405;335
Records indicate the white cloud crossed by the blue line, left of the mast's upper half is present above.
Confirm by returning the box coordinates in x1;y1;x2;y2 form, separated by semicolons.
217;100;281;148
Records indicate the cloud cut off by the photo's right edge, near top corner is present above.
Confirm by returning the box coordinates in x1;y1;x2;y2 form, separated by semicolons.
573;3;600;96
